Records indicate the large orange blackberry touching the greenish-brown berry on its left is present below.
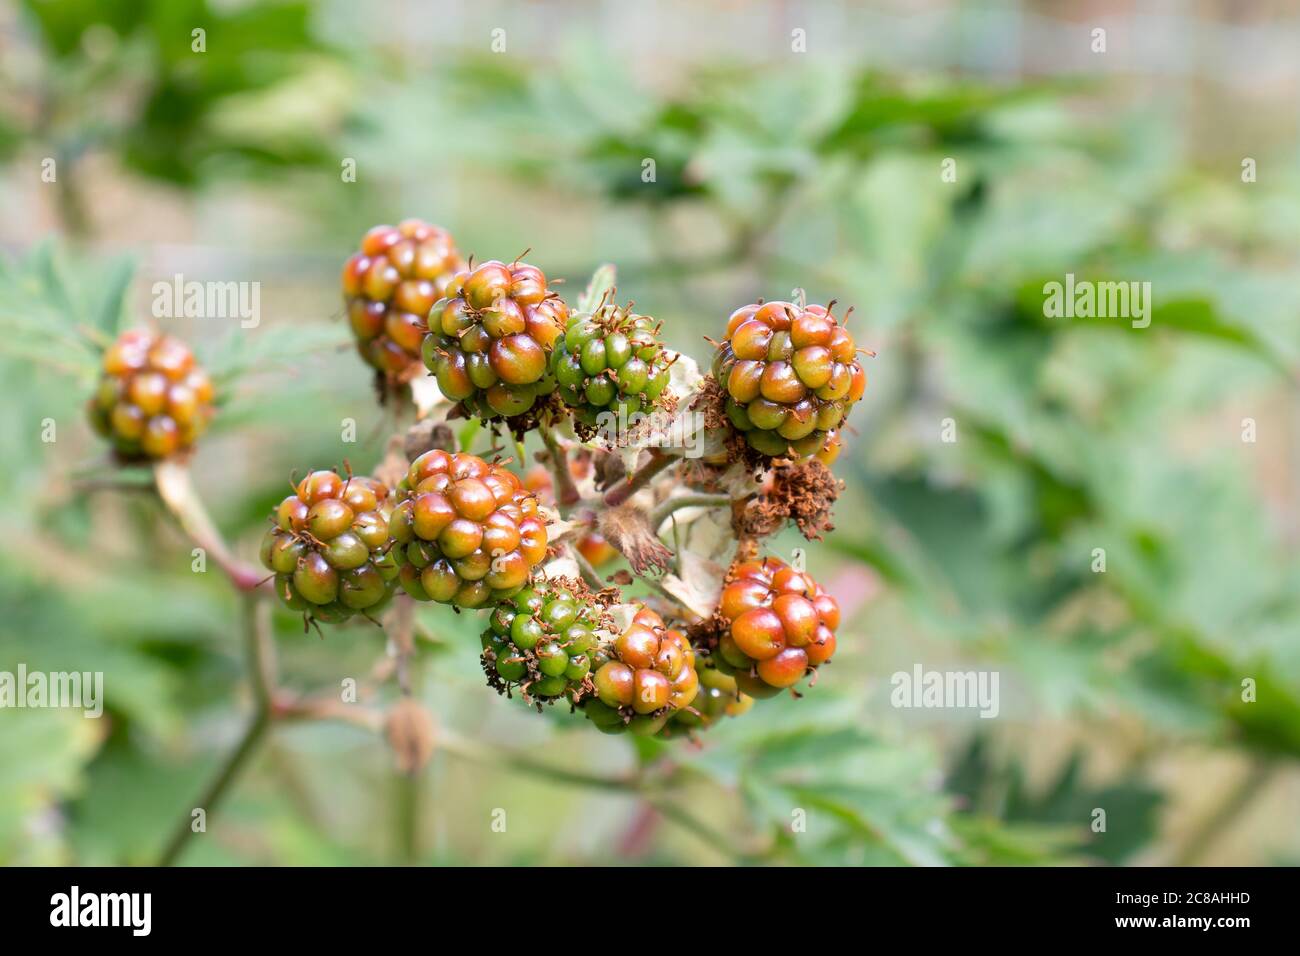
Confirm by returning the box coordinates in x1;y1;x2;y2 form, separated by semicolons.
389;449;546;607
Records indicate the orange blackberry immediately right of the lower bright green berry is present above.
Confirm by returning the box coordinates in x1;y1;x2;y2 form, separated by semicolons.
582;607;699;736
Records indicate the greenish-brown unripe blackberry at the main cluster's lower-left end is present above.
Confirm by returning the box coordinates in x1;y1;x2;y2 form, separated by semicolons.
261;471;398;622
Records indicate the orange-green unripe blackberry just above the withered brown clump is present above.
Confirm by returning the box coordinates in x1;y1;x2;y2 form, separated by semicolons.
712;302;867;458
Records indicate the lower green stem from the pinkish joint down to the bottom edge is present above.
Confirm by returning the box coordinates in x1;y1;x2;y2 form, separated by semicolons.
159;593;276;866
